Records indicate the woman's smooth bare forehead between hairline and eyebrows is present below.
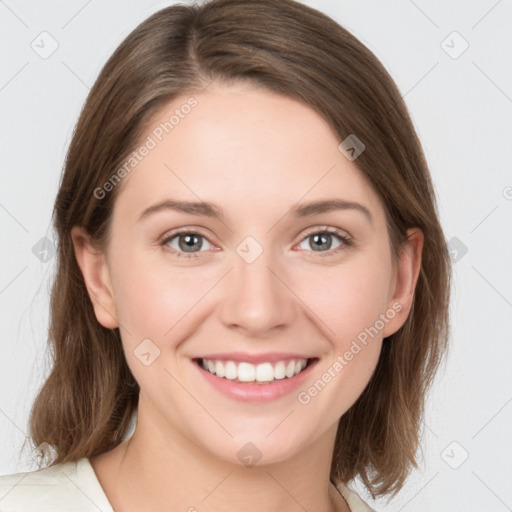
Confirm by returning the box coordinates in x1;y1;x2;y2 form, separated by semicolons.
115;84;382;224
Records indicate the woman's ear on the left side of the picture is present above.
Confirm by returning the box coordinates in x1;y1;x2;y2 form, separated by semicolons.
71;226;119;329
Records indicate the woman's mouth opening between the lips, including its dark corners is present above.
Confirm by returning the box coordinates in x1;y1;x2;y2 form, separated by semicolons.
193;357;318;385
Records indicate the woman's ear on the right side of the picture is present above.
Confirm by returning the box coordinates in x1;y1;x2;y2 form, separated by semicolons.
382;228;424;338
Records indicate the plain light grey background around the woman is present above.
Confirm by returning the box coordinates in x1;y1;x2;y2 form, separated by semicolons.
0;0;512;512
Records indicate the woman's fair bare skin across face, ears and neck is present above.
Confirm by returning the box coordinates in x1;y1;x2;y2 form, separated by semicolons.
72;84;423;512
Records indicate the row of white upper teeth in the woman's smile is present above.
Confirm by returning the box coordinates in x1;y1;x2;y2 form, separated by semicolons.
201;359;308;382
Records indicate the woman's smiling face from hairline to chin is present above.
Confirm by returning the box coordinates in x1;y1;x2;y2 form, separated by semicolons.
76;81;416;463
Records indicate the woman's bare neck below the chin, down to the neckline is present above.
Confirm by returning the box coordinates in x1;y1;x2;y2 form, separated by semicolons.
91;403;349;512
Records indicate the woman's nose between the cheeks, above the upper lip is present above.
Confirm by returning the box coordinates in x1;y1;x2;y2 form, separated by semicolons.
220;246;297;338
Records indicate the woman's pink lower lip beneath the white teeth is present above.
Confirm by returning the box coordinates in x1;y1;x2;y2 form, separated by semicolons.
193;359;318;402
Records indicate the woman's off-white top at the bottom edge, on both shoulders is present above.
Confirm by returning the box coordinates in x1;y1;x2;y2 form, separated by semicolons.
0;458;374;512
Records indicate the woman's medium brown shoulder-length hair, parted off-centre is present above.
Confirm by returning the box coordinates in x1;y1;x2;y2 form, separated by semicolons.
29;0;451;497
